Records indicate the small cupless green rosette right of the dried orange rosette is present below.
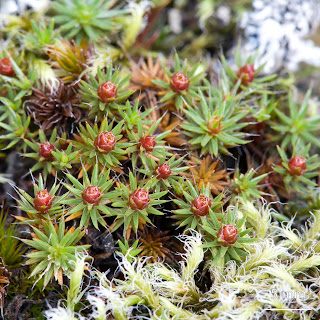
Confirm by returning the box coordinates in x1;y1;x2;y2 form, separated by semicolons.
230;168;268;203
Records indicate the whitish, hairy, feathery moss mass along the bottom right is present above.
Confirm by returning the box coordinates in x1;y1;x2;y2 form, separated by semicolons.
46;201;320;320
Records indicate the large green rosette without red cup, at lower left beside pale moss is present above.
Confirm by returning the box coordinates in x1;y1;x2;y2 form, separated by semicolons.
21;217;90;288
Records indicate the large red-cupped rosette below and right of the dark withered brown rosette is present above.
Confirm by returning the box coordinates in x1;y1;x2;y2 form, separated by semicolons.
72;118;132;172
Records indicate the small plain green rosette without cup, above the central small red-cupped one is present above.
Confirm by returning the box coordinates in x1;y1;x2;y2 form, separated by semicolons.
115;100;153;131
